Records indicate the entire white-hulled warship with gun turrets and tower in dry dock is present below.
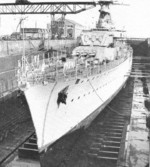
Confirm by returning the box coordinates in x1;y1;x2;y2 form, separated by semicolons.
18;1;133;152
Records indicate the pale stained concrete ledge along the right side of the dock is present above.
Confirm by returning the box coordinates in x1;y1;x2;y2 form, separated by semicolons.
125;78;149;167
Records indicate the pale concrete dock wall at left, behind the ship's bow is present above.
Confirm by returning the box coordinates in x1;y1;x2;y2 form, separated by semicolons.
0;40;77;97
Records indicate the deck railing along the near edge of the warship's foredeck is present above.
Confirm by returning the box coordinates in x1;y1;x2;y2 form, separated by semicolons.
18;58;126;85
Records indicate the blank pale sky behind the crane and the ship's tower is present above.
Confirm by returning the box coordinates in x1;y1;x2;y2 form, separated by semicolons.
0;0;150;38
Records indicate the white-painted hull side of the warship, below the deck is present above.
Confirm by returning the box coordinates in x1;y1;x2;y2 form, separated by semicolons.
25;57;132;152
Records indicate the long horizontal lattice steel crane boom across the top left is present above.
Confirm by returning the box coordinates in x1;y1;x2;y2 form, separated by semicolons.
0;2;96;15
